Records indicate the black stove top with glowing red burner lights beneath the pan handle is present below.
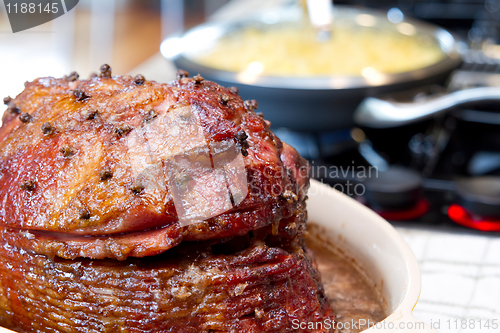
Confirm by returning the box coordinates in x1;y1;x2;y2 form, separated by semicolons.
275;63;500;234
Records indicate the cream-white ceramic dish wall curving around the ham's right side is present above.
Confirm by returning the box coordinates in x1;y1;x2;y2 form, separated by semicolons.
307;180;437;333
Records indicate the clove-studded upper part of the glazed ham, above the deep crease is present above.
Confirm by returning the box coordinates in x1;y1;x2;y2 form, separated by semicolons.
0;72;308;260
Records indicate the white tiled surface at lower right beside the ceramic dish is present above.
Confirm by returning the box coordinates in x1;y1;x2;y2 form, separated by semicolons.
397;228;500;333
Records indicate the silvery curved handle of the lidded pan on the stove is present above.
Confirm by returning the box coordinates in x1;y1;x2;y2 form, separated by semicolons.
354;87;500;128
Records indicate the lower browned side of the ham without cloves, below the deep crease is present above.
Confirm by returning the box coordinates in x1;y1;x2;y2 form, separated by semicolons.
0;208;334;333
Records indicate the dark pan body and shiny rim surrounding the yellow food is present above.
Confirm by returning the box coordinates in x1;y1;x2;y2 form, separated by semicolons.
161;6;461;131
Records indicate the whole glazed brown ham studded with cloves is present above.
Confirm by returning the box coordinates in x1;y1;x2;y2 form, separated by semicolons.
0;65;334;332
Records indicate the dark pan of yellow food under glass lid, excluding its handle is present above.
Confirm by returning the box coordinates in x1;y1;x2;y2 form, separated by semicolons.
161;6;461;131
